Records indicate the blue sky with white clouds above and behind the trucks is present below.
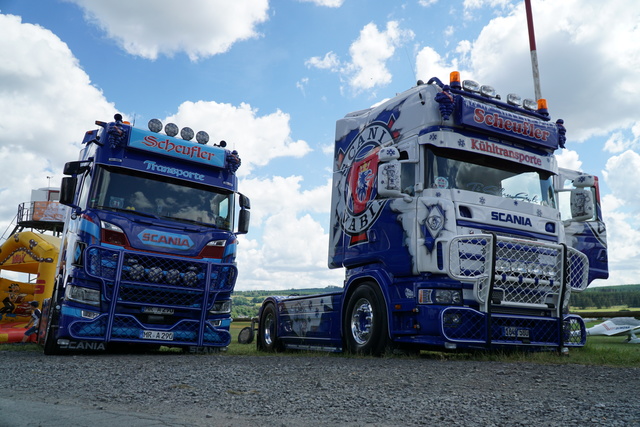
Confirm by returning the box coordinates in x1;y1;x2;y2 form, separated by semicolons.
0;0;640;291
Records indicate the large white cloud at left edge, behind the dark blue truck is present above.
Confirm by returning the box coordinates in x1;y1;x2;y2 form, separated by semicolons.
0;14;116;232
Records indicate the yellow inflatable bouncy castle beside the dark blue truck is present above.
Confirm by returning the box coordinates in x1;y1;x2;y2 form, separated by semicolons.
0;231;60;343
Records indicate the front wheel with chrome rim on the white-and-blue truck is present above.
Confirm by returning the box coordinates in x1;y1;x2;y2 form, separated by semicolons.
343;282;389;356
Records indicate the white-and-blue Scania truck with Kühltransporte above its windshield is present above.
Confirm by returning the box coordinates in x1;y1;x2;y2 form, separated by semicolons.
257;72;608;355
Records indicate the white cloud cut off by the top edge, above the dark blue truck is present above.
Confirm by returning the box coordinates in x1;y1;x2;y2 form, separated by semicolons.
67;0;269;61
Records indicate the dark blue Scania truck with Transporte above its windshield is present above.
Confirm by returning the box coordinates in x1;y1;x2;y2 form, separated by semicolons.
38;114;250;354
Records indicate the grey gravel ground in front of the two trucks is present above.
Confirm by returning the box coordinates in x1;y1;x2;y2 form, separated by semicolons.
0;351;640;427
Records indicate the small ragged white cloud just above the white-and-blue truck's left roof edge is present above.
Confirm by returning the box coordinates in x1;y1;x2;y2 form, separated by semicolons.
305;21;414;93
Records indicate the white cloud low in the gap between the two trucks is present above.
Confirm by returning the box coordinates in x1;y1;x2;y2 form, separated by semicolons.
237;176;344;290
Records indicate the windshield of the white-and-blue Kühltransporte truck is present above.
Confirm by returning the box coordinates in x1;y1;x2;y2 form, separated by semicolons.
426;147;556;207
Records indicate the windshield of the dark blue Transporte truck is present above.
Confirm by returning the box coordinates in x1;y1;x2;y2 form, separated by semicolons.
89;167;233;230
